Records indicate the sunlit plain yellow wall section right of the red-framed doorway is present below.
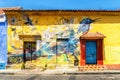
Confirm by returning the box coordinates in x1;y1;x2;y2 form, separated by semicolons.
91;23;120;64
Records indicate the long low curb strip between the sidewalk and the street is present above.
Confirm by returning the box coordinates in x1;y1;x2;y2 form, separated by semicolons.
0;70;120;75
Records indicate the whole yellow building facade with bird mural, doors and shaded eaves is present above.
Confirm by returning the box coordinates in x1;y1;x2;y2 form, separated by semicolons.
1;9;120;69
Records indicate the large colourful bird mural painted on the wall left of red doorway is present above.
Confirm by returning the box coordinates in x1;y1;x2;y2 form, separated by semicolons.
8;14;98;69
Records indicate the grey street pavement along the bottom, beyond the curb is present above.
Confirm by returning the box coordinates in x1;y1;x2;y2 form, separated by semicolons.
0;74;120;80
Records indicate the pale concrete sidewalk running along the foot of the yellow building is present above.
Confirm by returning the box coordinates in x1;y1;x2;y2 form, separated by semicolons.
0;68;120;75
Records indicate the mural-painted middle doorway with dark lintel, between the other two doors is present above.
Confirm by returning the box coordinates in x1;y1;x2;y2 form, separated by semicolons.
56;38;69;64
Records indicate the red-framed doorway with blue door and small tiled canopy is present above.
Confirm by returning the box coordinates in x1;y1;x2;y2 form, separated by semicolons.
80;32;105;66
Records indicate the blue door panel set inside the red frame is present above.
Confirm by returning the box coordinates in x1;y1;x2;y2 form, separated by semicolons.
86;41;97;64
